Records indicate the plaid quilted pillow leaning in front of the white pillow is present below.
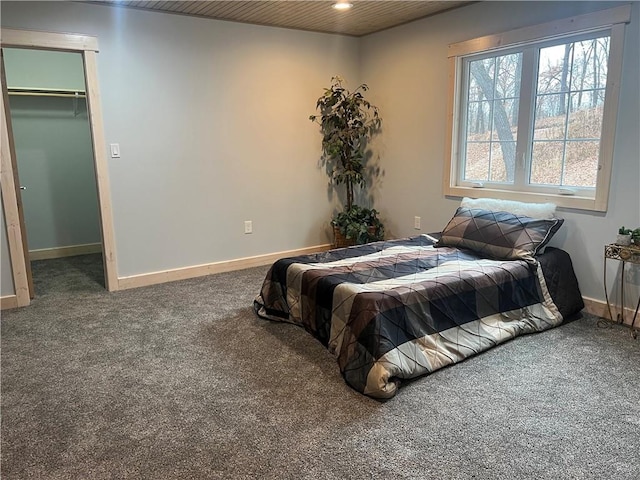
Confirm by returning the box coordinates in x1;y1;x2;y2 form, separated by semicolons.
436;207;564;262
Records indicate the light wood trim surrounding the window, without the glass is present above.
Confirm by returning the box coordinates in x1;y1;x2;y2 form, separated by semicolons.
443;5;631;212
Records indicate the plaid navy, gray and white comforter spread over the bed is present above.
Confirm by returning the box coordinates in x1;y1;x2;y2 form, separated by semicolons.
254;235;563;399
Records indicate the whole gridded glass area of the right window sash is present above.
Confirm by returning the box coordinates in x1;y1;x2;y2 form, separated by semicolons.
529;37;609;187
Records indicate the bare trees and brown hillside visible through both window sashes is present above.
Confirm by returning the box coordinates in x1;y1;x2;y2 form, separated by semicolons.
464;36;609;188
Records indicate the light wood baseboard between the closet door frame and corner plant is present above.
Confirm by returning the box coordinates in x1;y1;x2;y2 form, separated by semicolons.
118;244;331;290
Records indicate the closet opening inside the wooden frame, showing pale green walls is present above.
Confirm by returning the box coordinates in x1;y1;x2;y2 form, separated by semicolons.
2;48;104;295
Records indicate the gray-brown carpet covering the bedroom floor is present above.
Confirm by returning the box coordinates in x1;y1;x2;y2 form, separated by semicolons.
1;255;640;480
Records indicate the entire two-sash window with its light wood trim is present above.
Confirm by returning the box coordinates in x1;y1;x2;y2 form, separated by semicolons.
445;7;630;211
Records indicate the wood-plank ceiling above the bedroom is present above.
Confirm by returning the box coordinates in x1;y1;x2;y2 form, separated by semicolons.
91;0;475;37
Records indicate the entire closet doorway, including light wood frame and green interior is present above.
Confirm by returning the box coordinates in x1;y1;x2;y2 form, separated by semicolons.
1;30;117;306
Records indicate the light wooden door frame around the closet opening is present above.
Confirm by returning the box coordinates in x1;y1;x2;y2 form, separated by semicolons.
0;28;118;307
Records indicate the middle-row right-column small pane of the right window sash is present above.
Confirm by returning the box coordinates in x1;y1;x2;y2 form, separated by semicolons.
567;90;604;139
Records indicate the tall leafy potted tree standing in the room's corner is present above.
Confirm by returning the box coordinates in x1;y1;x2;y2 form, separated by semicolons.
309;76;384;246
